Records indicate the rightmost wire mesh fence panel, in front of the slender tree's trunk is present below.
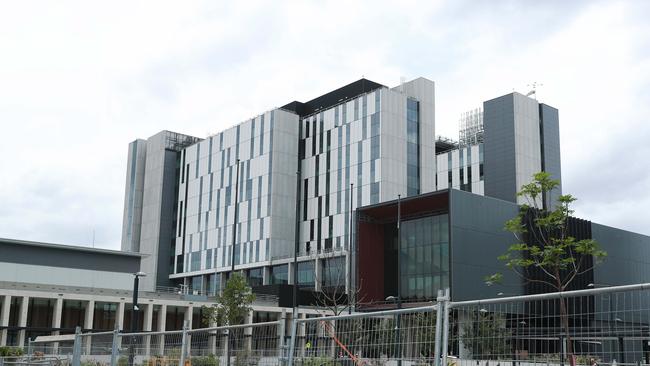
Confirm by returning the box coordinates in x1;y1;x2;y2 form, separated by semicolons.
448;285;650;366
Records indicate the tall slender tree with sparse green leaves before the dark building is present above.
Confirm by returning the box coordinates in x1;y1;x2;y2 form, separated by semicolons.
486;172;607;365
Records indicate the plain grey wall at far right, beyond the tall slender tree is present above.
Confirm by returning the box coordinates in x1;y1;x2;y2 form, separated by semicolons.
591;223;650;285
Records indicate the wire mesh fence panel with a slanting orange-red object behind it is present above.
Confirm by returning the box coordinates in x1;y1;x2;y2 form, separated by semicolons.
292;305;438;366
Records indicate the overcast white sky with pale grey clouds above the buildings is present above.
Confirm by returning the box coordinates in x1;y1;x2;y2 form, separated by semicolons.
0;0;650;249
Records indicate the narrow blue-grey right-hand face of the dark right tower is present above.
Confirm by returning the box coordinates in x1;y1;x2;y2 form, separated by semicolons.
539;104;562;206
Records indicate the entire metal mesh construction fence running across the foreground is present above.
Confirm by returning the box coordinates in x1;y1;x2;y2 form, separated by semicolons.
11;284;650;366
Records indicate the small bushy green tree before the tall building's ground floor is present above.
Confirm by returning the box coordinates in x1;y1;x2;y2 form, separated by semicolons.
201;273;255;326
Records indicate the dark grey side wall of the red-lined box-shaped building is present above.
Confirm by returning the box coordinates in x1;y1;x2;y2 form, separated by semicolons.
450;190;522;300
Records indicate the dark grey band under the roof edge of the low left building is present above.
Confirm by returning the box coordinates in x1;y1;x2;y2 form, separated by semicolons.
0;240;140;273
